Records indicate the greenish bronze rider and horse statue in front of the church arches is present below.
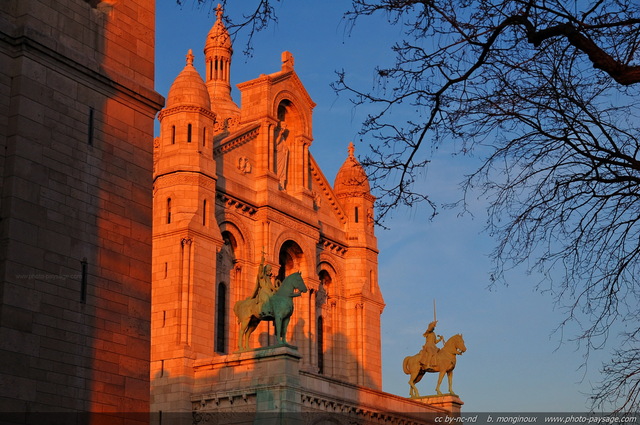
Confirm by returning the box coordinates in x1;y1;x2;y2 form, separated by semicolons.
233;253;307;351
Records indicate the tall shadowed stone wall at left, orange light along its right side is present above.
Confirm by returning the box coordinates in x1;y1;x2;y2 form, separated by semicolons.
0;0;164;423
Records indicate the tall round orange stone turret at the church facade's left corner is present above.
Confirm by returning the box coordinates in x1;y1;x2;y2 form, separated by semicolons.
151;50;223;411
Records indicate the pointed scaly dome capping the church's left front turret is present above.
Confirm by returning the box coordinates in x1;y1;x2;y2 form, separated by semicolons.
166;49;211;110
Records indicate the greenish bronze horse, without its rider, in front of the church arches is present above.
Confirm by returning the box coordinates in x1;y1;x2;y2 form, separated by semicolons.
233;272;307;351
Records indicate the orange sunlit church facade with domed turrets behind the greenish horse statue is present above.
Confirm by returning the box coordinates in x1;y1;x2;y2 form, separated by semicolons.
151;9;459;423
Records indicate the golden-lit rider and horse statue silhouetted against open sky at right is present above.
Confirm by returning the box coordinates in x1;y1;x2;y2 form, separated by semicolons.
402;320;467;398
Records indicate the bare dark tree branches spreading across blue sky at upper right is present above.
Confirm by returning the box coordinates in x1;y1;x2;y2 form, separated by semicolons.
335;0;640;409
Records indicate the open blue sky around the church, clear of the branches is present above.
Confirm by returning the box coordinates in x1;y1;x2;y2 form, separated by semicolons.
156;0;610;412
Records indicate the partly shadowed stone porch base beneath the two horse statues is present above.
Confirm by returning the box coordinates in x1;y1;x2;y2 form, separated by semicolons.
188;347;462;425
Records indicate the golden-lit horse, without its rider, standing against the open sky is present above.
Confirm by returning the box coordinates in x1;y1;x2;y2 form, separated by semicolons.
402;334;467;398
